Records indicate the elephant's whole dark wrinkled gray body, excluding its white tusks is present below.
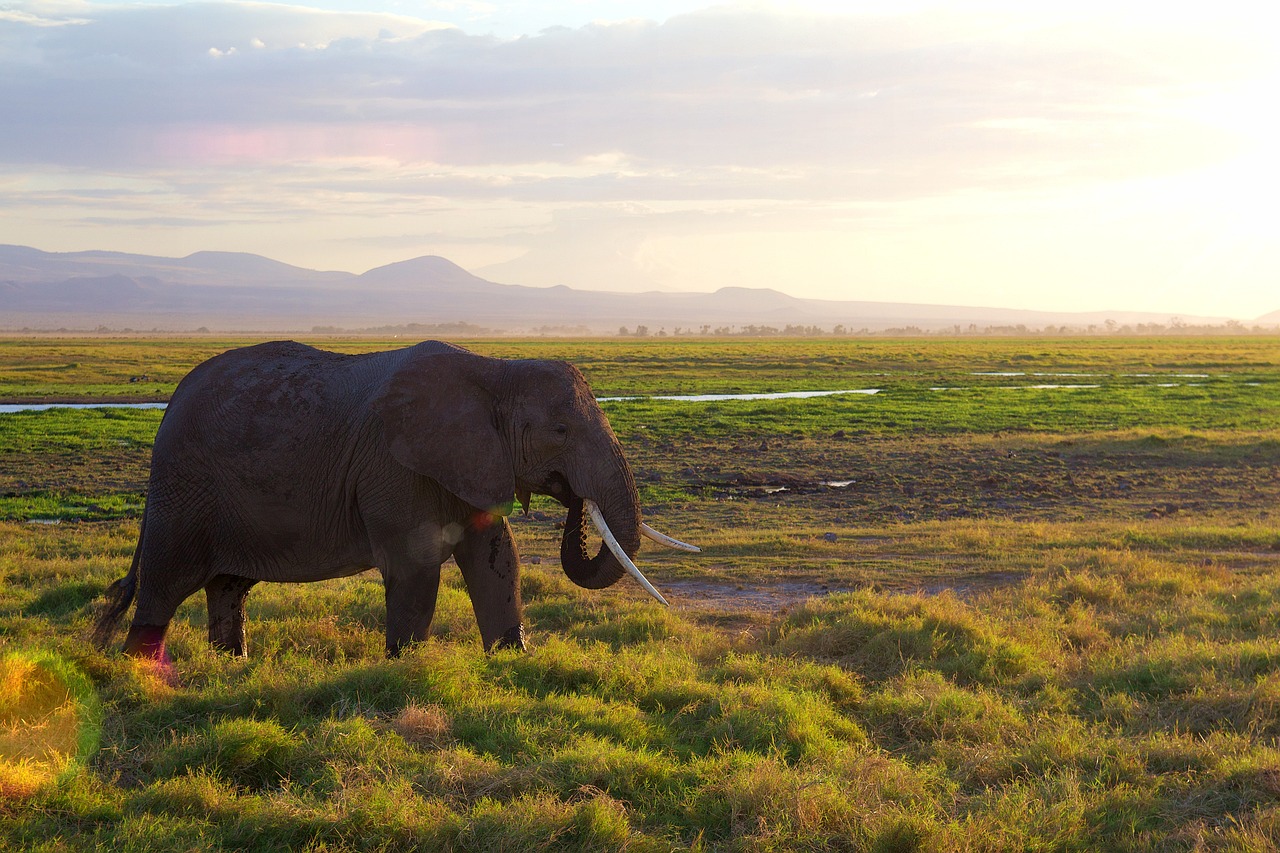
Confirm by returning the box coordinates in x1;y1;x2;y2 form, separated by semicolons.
95;341;640;658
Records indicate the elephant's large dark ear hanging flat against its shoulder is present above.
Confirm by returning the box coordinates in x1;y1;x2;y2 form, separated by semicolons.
374;352;516;515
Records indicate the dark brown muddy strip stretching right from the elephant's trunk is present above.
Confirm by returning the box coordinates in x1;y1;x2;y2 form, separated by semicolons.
632;434;1280;524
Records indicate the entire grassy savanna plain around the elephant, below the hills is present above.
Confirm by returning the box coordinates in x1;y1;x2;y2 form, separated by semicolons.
0;336;1280;850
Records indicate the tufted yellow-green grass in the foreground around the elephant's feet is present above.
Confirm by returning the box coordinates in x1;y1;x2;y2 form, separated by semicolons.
0;523;1280;850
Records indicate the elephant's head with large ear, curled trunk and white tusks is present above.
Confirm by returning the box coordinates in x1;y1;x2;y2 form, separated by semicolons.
375;350;680;601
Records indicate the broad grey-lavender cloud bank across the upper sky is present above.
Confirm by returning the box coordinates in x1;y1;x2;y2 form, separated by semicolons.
0;3;1244;188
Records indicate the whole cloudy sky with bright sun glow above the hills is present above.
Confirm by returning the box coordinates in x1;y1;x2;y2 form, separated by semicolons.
0;0;1280;320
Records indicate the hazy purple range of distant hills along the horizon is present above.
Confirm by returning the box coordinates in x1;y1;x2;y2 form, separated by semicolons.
0;246;1259;333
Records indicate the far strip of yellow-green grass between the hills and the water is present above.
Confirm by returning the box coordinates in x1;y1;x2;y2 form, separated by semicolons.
0;336;1280;400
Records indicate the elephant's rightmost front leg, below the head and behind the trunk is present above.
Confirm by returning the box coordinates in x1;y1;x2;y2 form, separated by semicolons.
453;515;525;651
